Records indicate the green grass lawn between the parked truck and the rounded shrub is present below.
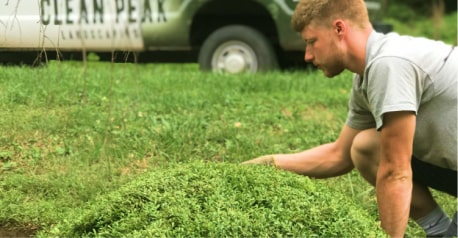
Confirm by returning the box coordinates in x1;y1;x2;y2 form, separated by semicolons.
0;62;456;236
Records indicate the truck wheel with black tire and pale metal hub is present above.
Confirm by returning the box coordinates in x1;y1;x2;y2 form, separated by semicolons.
198;25;278;74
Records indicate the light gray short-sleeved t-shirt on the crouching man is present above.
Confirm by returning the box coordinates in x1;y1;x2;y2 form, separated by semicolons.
347;32;458;170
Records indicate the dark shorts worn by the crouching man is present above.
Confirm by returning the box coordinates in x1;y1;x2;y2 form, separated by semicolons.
412;157;457;197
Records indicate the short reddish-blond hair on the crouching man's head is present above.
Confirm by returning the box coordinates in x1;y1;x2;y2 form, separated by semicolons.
291;0;370;32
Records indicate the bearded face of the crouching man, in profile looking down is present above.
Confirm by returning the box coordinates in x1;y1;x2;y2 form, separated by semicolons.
301;24;345;78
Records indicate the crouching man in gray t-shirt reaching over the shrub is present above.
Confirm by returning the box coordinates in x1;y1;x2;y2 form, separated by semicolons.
244;0;458;237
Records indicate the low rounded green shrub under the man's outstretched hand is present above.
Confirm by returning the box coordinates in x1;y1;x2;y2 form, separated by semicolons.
43;162;383;237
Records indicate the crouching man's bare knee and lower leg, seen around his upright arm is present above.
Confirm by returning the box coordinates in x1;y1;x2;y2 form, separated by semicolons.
351;129;450;235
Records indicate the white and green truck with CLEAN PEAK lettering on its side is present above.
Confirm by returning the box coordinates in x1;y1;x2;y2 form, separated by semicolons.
0;0;390;73
